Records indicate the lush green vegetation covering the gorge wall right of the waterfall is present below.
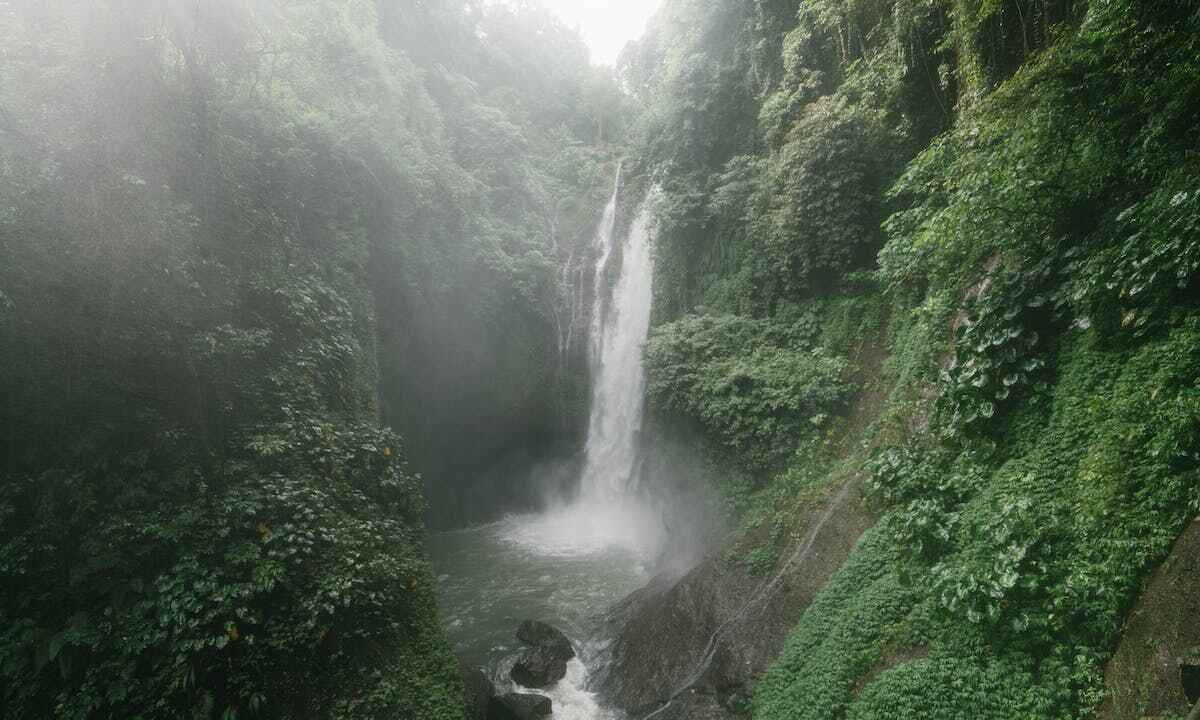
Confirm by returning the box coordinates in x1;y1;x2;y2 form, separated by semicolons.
623;0;1200;719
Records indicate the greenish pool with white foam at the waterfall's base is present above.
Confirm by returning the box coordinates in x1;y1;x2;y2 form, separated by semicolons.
431;506;652;720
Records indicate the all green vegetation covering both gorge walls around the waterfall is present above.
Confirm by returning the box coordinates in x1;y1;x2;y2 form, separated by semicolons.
0;0;1200;720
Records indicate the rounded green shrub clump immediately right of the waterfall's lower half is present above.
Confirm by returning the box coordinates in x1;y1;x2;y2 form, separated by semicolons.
646;314;851;470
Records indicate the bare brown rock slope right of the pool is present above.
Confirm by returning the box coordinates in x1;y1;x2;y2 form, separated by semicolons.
601;480;874;720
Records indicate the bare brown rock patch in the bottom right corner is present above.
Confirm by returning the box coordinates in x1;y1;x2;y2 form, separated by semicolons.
1099;520;1200;720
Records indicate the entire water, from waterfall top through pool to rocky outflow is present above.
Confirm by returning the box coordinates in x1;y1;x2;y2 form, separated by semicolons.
432;170;665;720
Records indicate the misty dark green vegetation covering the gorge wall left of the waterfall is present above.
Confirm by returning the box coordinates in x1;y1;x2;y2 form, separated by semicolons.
0;0;622;720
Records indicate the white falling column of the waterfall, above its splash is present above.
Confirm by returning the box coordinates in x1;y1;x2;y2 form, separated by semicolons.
580;170;654;500
